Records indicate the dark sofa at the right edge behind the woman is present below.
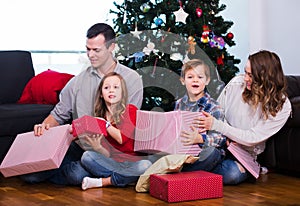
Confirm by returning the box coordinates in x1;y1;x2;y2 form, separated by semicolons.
259;75;300;177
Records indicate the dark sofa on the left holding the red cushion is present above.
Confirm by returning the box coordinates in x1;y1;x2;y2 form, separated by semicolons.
0;51;54;162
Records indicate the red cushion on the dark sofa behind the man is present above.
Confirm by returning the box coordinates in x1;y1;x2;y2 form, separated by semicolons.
18;69;74;104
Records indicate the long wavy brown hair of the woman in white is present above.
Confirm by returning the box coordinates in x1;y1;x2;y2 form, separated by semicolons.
243;50;287;119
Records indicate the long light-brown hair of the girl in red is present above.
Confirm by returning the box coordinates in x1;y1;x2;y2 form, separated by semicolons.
94;72;128;124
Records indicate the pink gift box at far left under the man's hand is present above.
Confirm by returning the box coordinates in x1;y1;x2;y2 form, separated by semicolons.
0;125;74;177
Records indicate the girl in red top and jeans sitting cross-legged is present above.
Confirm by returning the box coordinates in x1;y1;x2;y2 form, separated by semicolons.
81;72;152;190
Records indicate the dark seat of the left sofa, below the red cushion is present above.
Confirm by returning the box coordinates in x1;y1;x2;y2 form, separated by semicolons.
0;104;54;137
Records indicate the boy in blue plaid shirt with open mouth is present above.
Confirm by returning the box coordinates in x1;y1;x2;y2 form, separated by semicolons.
175;59;226;171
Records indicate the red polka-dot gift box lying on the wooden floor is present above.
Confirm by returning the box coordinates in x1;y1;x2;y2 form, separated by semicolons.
149;171;223;202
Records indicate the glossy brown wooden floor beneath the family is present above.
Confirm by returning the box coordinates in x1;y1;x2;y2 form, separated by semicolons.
0;173;300;206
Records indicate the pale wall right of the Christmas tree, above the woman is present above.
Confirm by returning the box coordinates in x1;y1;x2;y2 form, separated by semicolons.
225;0;300;74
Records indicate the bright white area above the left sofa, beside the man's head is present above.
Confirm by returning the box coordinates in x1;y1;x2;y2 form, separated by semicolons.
0;0;117;50
